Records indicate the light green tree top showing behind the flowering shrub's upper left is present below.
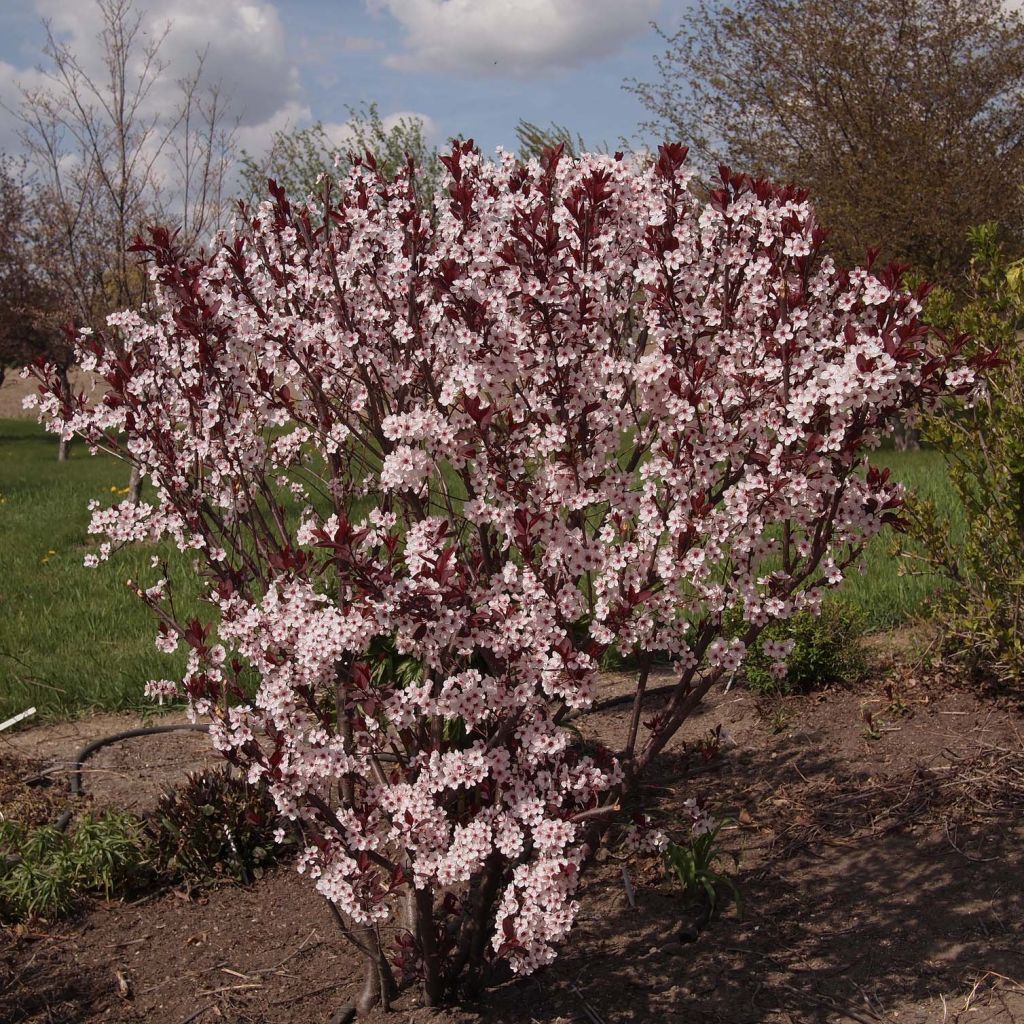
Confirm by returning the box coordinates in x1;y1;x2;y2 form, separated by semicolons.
241;103;441;207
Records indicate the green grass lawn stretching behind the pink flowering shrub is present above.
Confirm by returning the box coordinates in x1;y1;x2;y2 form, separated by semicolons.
0;419;955;719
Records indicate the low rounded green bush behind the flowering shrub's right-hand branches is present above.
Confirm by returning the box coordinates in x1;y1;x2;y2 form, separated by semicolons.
736;601;865;694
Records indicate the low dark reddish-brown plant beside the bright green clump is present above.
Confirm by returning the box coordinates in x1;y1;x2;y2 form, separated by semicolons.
147;766;282;886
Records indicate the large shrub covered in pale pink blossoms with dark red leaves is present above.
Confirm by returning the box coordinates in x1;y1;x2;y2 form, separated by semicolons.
28;143;987;1005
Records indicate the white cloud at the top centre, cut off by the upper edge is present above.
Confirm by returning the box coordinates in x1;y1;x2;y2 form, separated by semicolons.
368;0;660;76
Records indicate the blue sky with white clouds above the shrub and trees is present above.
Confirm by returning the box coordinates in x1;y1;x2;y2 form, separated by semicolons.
0;0;690;181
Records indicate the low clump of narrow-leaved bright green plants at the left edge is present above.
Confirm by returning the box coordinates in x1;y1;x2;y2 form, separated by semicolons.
0;813;151;925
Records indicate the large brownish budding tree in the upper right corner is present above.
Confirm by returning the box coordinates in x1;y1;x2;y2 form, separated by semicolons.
627;0;1024;284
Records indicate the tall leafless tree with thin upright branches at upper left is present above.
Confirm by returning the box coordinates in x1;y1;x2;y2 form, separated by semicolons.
16;0;233;475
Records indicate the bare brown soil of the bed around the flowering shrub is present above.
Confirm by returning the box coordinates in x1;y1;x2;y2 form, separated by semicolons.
0;671;1024;1024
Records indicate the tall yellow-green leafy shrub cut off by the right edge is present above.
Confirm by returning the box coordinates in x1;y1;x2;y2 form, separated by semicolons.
902;224;1024;686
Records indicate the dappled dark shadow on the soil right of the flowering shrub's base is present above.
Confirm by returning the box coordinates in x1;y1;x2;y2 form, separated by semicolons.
475;743;1024;1024
